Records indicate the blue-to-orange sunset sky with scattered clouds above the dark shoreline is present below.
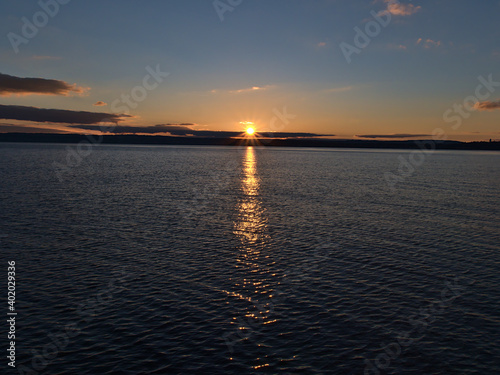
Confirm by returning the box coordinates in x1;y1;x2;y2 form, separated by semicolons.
0;0;500;141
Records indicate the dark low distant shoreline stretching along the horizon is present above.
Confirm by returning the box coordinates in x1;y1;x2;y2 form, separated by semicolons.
0;133;500;151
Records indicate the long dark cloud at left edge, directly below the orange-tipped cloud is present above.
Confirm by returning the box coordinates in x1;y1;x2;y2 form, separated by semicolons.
0;104;132;124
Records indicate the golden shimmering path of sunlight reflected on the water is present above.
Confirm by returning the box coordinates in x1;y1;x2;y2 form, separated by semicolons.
229;147;276;369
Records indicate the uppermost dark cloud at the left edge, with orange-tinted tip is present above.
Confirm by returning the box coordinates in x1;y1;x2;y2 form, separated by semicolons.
0;73;88;96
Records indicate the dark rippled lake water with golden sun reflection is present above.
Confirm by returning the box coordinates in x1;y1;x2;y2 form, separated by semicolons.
0;144;500;375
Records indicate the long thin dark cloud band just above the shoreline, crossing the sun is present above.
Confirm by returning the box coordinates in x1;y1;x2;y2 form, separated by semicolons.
71;123;328;138
